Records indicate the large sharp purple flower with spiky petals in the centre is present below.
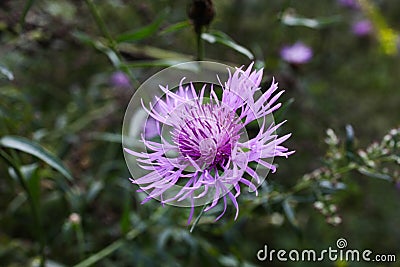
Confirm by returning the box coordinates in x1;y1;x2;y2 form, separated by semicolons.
125;64;294;223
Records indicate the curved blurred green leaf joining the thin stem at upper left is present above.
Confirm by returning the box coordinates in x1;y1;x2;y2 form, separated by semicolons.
115;10;169;43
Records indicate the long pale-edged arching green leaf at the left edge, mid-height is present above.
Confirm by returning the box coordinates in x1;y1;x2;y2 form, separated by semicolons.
0;136;73;181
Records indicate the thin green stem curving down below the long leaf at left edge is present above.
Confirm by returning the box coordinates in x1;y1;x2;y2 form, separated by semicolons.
0;150;46;267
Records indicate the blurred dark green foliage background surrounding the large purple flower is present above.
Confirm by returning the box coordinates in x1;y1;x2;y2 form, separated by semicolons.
0;0;400;267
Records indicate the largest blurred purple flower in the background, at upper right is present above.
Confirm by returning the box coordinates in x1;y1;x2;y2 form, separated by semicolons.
281;42;313;65
